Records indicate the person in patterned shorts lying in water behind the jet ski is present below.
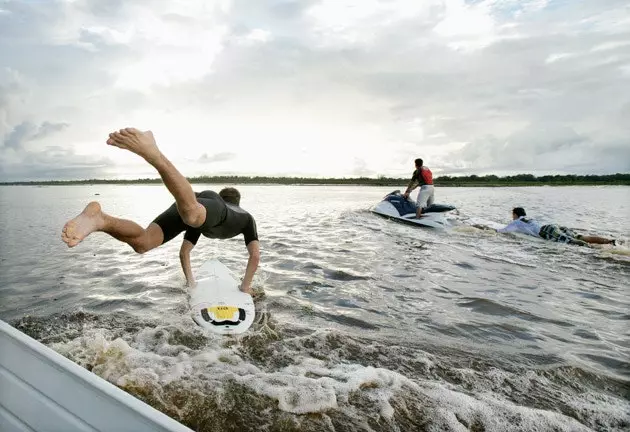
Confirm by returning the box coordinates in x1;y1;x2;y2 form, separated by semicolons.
496;207;616;246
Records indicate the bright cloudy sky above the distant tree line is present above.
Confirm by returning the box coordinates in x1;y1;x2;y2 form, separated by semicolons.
0;0;630;181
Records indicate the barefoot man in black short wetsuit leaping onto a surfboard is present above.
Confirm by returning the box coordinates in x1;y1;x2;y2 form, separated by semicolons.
61;128;260;294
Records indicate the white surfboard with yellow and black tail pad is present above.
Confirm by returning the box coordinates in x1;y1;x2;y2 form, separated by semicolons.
189;259;256;334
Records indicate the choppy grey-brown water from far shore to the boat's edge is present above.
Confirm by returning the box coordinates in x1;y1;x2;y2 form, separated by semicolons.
0;185;630;431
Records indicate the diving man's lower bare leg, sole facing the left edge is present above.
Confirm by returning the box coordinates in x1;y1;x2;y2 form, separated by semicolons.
61;201;164;253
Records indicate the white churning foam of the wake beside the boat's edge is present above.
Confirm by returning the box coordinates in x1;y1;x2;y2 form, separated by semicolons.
54;327;627;432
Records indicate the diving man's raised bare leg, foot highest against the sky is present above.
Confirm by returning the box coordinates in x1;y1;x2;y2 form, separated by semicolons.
107;128;206;228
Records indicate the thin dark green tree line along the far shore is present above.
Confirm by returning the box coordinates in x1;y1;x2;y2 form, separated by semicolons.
0;174;630;187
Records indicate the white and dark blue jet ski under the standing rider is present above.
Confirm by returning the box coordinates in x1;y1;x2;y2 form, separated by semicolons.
370;190;455;228
